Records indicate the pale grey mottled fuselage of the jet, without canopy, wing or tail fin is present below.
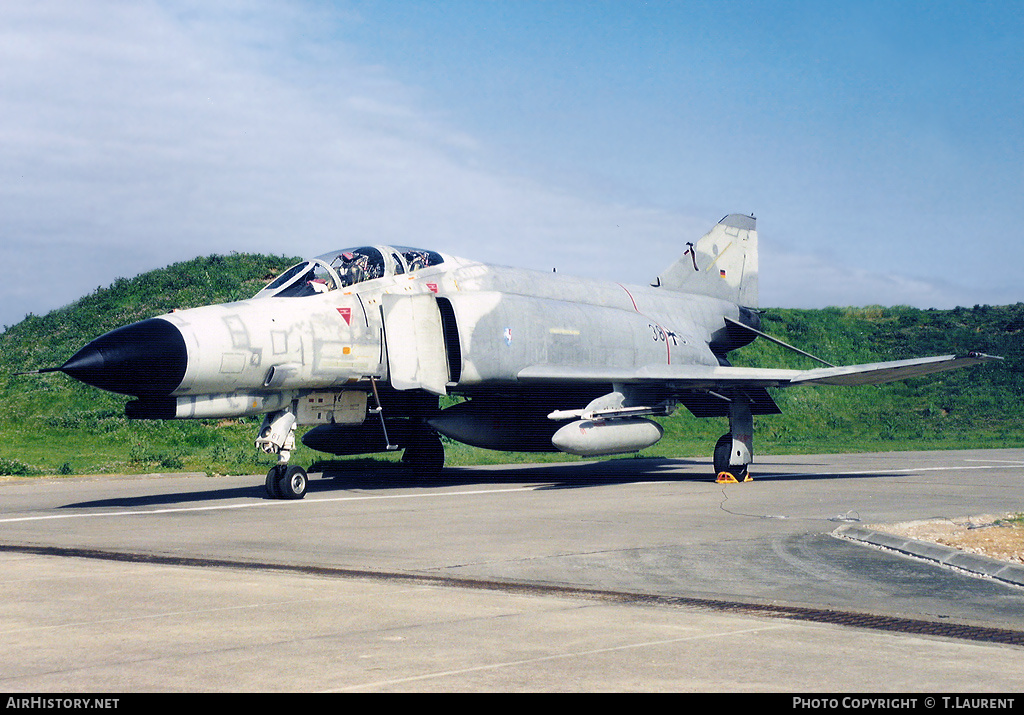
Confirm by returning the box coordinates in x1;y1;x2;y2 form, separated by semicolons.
66;251;741;418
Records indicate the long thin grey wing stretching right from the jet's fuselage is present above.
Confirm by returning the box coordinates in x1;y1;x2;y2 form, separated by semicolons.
517;352;1002;389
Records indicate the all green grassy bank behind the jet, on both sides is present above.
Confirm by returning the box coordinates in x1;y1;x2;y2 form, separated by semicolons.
0;254;1024;474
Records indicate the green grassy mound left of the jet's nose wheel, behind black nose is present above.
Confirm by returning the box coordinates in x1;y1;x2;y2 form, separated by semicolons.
0;254;299;474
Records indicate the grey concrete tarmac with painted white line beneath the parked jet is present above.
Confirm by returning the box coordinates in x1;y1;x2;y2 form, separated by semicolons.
0;450;1024;693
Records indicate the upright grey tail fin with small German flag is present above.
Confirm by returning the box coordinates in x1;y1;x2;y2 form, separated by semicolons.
652;213;758;307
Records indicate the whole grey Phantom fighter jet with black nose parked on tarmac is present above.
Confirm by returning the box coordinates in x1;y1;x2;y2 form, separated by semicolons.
40;214;996;499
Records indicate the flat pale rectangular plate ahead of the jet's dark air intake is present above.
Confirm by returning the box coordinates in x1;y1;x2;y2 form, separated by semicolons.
382;293;449;394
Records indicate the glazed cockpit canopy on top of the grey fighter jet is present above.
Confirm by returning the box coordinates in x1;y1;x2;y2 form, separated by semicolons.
255;246;444;298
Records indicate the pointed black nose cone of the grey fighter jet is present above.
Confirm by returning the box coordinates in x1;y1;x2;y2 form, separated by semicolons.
60;318;188;397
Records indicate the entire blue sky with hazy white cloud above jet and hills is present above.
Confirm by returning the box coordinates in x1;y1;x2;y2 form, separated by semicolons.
0;0;1024;325
